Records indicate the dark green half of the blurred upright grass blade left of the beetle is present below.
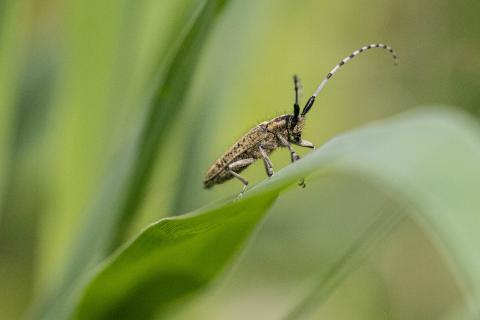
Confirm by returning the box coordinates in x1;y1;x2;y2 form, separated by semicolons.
111;0;234;249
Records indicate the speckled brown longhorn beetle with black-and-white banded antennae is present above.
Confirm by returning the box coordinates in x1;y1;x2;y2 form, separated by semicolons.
203;43;398;197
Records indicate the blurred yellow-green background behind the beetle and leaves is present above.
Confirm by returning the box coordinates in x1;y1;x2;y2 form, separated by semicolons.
0;0;480;319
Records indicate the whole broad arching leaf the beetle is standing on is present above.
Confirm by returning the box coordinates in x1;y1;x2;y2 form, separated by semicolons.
76;108;480;319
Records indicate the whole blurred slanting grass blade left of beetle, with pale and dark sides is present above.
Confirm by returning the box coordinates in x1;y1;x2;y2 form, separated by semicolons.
35;0;234;319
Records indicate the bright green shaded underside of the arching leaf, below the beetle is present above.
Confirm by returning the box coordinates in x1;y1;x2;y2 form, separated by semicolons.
77;193;276;319
